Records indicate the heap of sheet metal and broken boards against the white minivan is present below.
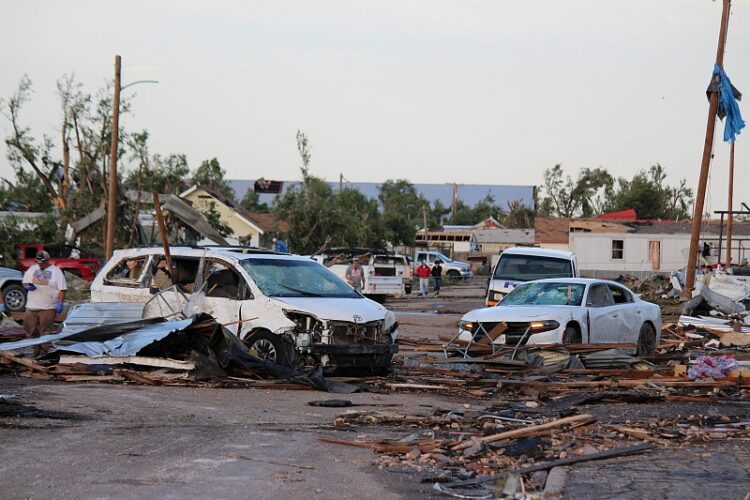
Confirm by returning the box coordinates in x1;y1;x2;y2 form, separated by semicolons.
0;314;357;393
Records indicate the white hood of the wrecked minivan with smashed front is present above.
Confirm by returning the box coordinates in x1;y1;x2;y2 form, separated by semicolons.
273;297;387;323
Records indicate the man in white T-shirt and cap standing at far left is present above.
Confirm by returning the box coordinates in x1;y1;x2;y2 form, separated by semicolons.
23;251;68;337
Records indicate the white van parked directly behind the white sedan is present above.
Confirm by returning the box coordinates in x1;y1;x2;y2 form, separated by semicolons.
486;247;579;307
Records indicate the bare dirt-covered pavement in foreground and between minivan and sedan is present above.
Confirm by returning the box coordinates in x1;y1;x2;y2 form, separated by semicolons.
0;279;750;499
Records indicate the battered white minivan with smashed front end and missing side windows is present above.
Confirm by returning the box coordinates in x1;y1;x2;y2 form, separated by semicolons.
91;246;398;372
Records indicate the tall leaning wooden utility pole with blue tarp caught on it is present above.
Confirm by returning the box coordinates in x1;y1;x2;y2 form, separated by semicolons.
682;0;732;300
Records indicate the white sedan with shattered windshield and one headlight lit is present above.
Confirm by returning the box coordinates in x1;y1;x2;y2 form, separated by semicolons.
458;278;661;355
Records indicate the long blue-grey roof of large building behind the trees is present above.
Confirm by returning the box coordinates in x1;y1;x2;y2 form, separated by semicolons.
227;179;534;208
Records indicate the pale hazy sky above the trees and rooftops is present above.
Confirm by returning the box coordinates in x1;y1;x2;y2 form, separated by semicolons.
0;0;750;210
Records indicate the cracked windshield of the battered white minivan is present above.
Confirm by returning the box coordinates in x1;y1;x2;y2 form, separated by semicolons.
241;259;362;299
